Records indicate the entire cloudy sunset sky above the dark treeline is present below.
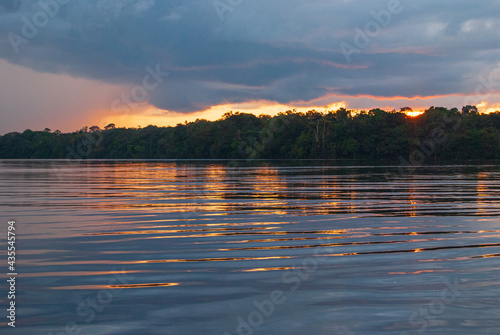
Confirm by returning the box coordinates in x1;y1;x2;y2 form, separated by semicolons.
0;0;500;134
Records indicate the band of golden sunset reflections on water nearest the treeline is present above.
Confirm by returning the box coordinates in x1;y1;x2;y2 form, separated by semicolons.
82;162;498;221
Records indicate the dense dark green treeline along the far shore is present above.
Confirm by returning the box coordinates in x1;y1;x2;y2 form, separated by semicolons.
0;106;500;161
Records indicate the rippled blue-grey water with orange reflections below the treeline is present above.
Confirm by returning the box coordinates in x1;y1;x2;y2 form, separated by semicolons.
0;161;500;335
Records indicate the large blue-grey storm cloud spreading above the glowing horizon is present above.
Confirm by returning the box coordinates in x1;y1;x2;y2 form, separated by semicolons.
0;0;500;112
